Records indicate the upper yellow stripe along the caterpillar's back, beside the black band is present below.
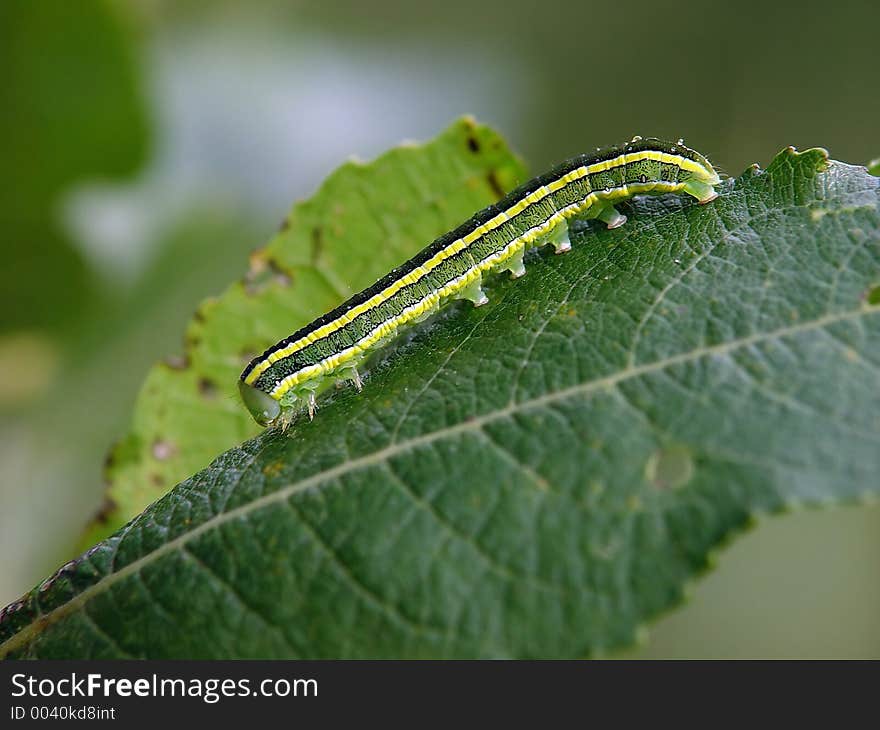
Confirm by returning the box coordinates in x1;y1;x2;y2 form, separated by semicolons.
245;150;702;385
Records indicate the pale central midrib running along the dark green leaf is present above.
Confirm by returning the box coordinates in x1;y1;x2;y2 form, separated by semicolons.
0;307;868;658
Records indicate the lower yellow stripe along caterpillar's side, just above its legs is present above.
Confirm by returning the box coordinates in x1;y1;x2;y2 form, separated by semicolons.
269;181;683;400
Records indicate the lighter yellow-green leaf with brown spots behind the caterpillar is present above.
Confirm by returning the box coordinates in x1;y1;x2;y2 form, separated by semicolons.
82;118;525;549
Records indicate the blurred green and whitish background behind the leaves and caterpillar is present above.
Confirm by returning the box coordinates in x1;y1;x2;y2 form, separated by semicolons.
0;0;880;657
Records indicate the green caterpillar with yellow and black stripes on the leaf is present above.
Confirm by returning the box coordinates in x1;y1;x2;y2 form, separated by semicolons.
238;137;720;429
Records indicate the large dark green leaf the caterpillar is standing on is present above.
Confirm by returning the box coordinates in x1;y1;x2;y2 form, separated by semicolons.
0;139;880;658
